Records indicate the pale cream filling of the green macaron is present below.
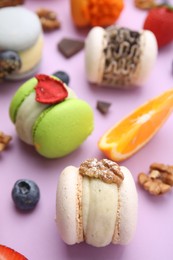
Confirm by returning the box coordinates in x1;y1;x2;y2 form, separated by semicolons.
15;87;76;145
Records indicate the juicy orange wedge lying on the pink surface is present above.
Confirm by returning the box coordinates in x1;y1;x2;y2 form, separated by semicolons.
98;89;173;161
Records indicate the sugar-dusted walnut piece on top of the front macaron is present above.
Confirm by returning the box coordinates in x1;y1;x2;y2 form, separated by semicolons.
79;158;124;186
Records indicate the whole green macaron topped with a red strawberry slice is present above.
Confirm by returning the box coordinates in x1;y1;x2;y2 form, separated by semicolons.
9;74;94;158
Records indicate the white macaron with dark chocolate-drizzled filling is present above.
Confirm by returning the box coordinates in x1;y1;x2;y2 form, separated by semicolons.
85;26;158;88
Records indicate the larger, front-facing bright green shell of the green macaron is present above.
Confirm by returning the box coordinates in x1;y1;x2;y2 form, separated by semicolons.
33;99;93;158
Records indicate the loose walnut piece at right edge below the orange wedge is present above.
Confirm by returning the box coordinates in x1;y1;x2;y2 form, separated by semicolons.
138;163;173;195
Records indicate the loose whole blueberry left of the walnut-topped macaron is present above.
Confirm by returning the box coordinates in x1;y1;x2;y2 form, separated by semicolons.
11;179;40;211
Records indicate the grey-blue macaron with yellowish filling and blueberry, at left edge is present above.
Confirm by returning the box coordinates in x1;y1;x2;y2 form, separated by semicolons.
0;6;43;80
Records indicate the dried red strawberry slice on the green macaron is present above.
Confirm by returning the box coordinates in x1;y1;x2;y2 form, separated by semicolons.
35;74;68;104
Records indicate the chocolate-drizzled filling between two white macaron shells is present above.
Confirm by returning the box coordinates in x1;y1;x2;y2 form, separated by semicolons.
102;26;142;86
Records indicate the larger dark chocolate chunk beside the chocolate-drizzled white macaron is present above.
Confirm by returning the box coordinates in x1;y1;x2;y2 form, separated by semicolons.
58;38;84;58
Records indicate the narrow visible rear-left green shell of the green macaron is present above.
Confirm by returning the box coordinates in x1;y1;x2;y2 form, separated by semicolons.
9;78;38;123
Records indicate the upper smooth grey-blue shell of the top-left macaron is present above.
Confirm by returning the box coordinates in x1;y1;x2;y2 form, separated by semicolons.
0;6;42;51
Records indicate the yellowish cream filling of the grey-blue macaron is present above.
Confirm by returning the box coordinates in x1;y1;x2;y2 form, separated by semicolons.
15;34;43;74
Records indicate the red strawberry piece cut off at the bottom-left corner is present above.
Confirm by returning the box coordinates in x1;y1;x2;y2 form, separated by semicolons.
0;245;27;260
